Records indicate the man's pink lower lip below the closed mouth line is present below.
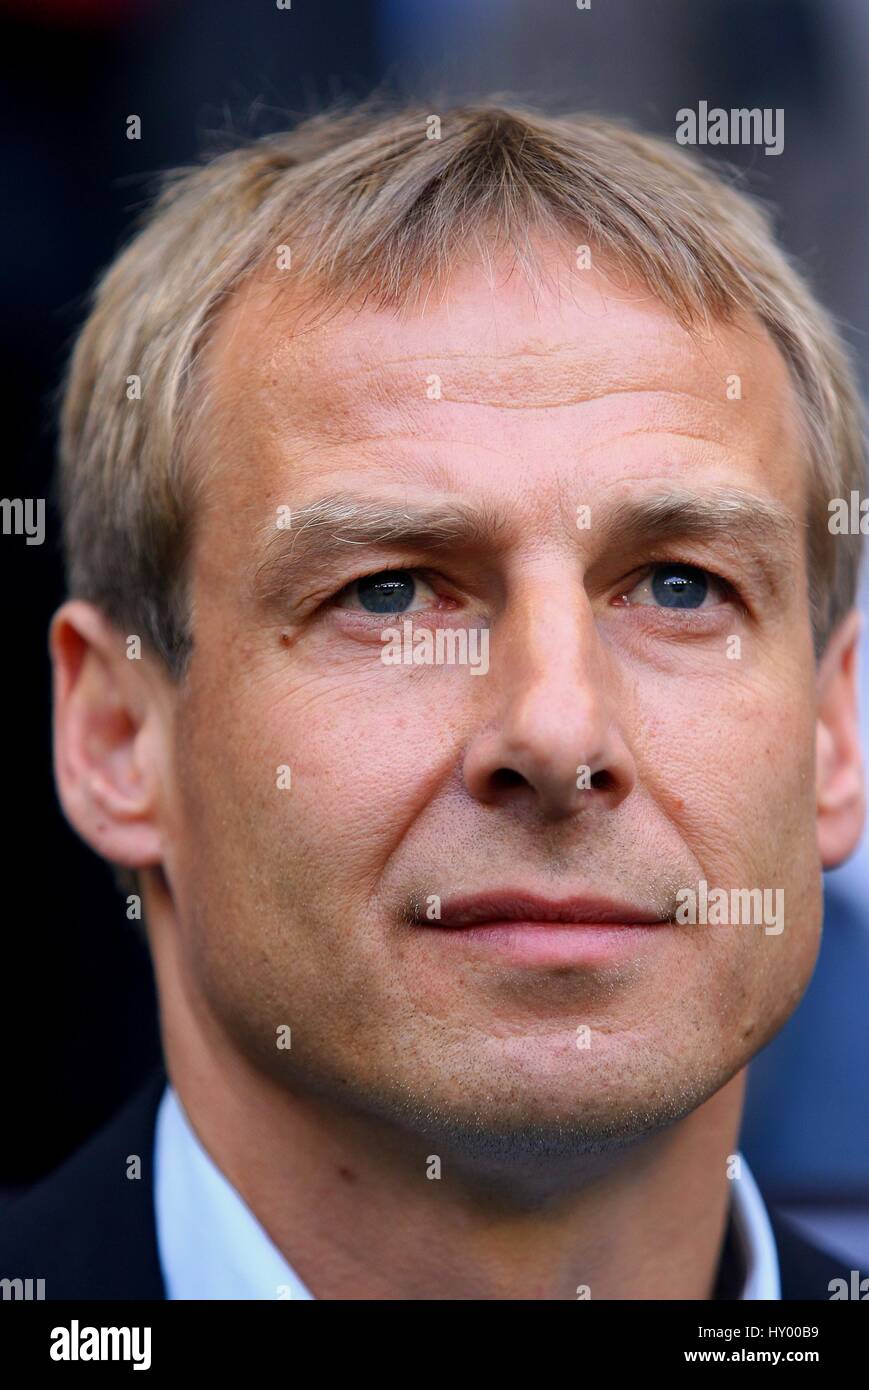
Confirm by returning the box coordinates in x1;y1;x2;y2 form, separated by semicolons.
424;922;673;966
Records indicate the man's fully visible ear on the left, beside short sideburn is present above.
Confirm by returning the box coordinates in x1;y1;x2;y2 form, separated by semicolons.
49;599;164;869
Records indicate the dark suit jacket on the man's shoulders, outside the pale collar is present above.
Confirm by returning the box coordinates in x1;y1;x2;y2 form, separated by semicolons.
0;1068;866;1300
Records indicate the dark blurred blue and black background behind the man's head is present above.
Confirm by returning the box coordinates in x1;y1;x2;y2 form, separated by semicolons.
0;0;869;1264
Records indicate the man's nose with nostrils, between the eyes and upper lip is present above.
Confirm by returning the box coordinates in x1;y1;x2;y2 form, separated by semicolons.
463;573;637;820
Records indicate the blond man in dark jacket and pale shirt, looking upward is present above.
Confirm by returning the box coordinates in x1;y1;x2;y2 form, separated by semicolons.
0;107;863;1300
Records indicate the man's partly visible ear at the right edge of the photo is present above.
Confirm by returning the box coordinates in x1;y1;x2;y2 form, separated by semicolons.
815;609;866;869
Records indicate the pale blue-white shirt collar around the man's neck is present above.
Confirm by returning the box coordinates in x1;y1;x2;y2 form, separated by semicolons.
154;1086;781;1300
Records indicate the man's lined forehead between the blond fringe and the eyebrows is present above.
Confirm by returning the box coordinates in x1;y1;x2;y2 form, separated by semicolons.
196;252;805;522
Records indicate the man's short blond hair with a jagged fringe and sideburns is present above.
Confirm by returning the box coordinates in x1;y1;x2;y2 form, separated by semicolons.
60;103;863;678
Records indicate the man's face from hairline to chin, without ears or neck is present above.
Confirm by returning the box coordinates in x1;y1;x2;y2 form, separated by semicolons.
165;247;820;1148
